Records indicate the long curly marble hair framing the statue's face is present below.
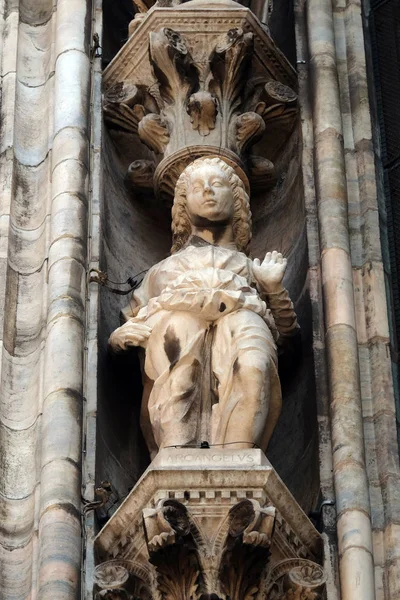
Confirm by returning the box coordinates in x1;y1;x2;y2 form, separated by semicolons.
171;157;251;254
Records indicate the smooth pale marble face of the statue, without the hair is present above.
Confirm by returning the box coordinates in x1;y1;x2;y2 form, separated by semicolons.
186;165;234;226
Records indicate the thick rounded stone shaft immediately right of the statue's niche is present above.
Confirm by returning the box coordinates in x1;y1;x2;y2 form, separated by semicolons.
308;0;375;600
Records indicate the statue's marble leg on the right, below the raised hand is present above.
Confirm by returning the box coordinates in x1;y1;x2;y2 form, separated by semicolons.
212;310;280;449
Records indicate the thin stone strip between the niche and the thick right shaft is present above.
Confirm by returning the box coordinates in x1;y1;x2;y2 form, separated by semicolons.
294;0;340;600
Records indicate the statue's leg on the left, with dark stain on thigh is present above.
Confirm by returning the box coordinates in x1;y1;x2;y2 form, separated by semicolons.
145;311;208;448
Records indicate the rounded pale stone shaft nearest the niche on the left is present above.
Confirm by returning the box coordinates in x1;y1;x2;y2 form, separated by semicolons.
38;0;90;600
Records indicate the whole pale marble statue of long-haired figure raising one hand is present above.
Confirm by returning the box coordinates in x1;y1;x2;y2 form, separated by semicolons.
110;158;298;457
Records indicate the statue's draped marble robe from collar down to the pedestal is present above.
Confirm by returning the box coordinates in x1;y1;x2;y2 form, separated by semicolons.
124;236;298;455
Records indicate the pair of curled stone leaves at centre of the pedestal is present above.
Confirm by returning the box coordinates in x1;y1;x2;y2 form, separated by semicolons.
144;500;275;600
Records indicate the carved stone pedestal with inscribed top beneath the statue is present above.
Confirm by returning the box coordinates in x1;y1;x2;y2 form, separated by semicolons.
95;449;325;600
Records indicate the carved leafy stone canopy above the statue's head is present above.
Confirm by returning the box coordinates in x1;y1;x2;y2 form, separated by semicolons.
104;0;297;200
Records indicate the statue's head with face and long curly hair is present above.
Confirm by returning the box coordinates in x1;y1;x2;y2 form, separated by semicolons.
171;158;251;252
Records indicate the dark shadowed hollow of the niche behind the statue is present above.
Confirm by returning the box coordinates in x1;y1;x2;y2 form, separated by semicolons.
96;0;319;512
